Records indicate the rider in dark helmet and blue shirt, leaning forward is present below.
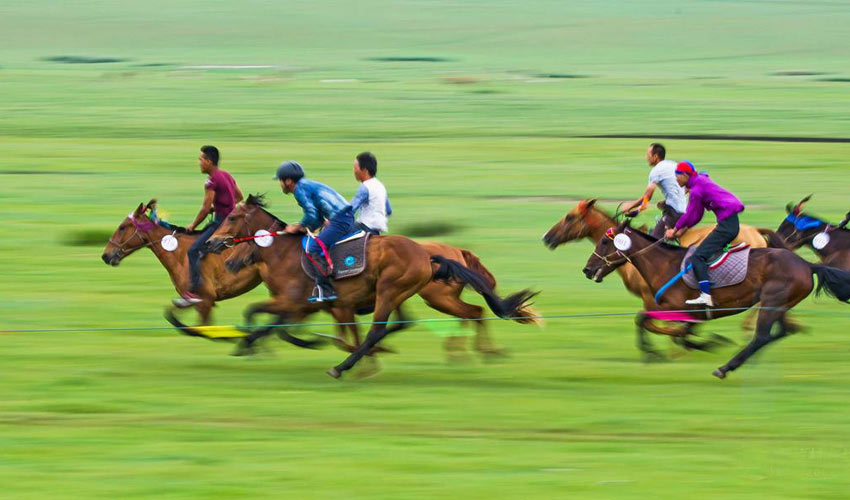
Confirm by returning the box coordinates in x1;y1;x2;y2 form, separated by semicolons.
275;161;356;302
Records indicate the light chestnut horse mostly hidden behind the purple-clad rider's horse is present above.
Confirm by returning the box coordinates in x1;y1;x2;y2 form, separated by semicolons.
543;198;796;349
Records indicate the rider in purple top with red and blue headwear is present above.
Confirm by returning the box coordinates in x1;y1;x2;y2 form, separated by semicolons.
665;161;744;307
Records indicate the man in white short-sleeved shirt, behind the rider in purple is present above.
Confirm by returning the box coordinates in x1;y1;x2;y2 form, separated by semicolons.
623;142;688;238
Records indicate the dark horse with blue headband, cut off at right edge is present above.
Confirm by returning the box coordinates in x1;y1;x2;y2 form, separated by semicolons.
776;195;850;271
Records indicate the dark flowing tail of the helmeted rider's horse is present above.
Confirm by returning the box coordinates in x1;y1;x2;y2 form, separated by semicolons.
431;255;537;323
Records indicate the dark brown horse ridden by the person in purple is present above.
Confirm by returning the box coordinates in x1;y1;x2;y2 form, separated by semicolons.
584;223;850;379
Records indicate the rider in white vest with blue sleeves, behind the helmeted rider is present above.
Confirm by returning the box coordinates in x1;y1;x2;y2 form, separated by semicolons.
351;151;393;234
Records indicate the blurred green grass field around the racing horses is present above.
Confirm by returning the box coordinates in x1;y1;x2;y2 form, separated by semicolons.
0;0;850;499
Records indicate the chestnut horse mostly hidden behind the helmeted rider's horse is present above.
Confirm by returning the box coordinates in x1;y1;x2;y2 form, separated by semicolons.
225;227;539;359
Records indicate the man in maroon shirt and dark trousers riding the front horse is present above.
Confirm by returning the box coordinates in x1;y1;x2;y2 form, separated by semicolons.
173;146;242;307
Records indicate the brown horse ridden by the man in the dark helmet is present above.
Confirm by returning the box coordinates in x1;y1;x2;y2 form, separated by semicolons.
207;195;535;379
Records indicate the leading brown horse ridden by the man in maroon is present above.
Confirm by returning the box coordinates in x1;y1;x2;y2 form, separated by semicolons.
101;200;262;328
